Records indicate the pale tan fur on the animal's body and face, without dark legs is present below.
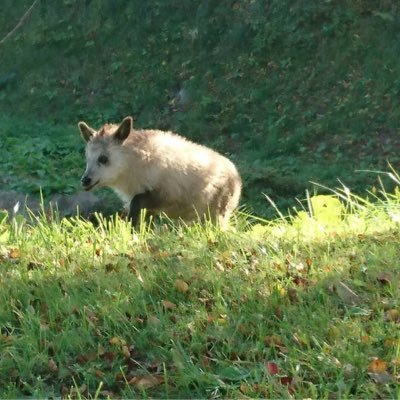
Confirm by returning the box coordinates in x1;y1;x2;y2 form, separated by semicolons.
80;120;241;225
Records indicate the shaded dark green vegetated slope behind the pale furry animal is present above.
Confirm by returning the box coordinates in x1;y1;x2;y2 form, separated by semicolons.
0;0;400;215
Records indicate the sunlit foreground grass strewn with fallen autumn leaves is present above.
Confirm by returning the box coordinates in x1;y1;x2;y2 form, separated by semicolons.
0;183;400;398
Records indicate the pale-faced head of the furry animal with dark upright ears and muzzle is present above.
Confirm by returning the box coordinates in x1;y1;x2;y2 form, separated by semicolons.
78;117;133;190
